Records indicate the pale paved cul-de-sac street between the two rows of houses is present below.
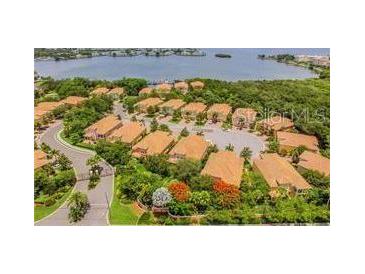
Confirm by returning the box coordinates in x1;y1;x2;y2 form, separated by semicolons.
114;103;266;159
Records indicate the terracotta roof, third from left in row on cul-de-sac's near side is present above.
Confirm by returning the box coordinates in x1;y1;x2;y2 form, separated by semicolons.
132;130;174;156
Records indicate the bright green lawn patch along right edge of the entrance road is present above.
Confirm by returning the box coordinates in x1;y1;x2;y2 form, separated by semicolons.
109;178;139;225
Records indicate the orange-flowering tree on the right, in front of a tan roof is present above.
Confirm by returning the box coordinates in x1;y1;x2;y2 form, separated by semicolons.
213;181;240;207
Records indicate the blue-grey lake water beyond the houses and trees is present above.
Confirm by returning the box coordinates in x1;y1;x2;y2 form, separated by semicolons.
34;48;330;81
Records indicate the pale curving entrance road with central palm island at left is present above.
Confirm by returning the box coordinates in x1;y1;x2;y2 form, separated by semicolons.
35;122;114;226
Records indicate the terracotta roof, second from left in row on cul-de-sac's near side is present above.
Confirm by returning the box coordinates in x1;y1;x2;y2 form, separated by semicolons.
108;122;146;144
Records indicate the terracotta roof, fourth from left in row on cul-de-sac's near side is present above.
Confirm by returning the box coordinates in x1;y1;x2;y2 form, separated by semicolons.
169;135;209;163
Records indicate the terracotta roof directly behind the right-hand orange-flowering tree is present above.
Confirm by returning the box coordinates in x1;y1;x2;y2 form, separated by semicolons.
201;150;243;187
